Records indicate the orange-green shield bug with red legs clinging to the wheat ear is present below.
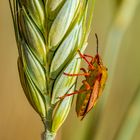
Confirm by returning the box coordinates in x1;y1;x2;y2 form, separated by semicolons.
60;34;107;120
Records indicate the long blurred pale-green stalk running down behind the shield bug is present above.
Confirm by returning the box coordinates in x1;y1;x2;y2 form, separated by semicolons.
93;0;140;140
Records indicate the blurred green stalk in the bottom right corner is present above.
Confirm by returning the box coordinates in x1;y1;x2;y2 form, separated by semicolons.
116;88;140;140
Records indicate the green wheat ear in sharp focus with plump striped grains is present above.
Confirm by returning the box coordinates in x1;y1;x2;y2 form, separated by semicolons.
9;0;94;140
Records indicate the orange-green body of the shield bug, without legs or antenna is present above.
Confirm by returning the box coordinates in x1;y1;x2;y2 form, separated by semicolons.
76;57;107;119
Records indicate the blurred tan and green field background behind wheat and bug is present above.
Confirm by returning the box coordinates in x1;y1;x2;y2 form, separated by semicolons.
0;0;140;140
